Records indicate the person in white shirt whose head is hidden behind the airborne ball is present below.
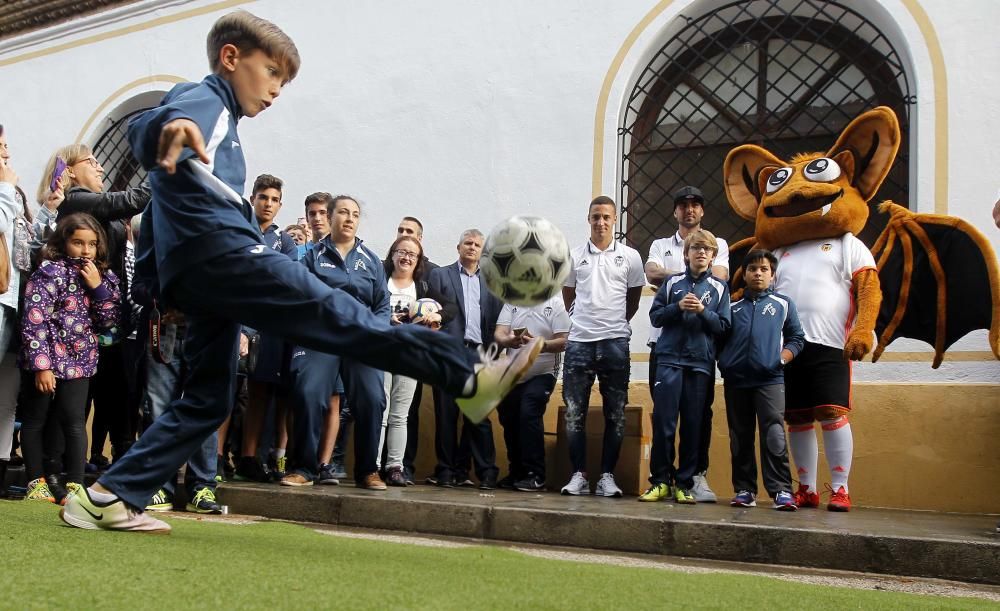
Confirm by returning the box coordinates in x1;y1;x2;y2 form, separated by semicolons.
493;295;570;492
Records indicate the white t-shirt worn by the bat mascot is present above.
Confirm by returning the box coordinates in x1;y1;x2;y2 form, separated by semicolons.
774;233;876;348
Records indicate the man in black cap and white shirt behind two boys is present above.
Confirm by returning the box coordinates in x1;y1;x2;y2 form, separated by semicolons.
643;185;729;503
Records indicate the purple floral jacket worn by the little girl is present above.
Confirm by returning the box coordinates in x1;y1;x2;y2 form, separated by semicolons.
21;259;121;380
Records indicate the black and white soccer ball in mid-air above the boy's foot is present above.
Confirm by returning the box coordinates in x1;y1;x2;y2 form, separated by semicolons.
479;216;572;306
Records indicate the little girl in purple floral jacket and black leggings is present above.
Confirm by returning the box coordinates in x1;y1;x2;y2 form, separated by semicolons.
21;214;120;502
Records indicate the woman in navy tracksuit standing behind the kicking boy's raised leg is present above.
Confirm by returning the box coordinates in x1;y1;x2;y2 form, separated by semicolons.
282;195;390;490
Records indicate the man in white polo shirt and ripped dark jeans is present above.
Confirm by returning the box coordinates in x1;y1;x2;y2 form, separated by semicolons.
562;195;646;497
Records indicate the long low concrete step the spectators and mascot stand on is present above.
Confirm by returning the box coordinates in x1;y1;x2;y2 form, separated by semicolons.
219;483;1000;585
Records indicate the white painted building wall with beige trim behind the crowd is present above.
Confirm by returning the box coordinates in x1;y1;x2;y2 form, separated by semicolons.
0;0;1000;381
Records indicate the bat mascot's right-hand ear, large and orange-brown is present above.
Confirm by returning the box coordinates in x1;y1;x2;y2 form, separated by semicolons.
826;106;900;201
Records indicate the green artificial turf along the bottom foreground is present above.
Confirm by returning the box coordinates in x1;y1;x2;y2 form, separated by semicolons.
0;501;990;611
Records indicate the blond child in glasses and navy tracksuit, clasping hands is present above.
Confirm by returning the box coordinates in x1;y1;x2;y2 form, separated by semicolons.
639;229;729;504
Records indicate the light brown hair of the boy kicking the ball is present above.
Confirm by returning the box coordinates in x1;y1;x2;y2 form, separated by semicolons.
208;11;302;82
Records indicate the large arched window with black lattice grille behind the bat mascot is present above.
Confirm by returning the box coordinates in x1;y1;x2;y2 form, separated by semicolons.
619;0;915;252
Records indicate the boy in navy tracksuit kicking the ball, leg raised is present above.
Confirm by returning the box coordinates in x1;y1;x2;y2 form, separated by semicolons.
59;11;543;533
